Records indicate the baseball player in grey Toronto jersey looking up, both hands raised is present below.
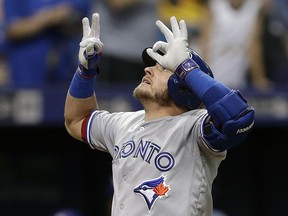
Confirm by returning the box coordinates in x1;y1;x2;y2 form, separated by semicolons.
65;13;254;216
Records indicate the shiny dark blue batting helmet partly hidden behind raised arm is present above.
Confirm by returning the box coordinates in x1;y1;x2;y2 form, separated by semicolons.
142;48;214;110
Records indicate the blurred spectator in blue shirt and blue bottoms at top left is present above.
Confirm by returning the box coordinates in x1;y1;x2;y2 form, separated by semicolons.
1;0;89;88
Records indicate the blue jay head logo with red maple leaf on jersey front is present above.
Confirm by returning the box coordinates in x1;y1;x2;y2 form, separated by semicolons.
134;176;170;212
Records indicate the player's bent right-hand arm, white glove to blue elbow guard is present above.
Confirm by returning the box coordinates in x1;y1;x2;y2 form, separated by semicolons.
147;17;254;151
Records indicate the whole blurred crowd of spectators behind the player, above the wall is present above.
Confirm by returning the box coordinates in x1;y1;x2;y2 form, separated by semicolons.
0;0;288;91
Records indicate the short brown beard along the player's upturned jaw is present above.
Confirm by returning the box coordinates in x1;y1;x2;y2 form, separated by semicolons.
133;86;172;106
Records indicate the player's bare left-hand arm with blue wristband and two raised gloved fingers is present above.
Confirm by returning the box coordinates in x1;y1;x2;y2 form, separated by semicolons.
64;13;103;141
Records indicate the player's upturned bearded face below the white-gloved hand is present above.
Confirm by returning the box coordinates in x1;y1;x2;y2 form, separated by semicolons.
133;64;173;105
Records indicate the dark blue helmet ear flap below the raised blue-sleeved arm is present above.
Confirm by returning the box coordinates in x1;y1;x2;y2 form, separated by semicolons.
168;74;201;110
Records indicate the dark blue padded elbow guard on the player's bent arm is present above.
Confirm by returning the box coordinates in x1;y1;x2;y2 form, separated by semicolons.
203;90;255;151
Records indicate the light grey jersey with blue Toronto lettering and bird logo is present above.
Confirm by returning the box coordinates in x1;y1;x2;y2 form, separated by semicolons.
84;109;226;216
